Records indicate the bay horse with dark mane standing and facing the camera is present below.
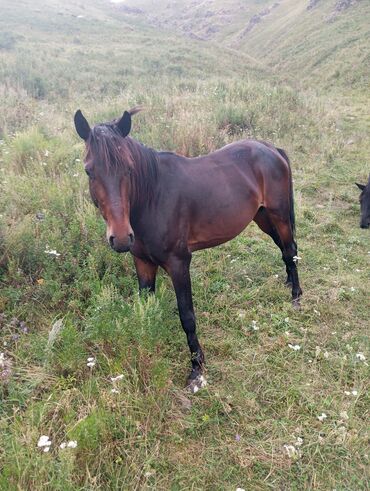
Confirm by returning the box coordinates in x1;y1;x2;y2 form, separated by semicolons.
74;108;302;391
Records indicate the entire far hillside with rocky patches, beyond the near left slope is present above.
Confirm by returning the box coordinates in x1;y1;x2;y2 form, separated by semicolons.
119;0;370;90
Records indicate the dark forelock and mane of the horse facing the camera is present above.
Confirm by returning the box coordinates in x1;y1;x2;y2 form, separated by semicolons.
87;123;158;208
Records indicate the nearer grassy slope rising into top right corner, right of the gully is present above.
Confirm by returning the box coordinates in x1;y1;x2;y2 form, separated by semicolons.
235;0;370;91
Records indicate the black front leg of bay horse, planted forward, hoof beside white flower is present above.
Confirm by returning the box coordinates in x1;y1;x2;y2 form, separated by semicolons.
165;254;206;392
